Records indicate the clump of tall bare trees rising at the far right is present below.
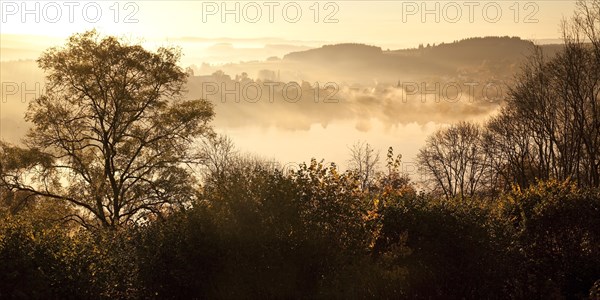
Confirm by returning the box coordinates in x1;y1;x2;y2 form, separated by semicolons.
487;0;600;187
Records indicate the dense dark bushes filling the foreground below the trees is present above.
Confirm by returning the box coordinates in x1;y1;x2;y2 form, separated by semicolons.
0;161;600;299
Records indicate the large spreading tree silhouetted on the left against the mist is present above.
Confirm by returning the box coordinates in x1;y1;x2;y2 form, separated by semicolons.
2;31;213;227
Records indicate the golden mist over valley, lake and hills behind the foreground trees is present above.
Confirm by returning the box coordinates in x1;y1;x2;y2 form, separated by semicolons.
0;36;561;165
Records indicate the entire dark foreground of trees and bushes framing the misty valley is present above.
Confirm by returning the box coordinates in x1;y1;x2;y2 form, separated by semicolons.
0;0;600;299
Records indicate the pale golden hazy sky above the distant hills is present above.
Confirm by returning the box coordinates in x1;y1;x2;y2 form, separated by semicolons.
0;0;575;57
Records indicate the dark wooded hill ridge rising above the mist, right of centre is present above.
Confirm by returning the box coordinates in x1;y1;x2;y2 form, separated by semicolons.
283;37;561;78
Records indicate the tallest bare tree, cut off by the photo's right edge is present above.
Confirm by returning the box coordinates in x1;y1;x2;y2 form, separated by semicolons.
550;0;600;187
